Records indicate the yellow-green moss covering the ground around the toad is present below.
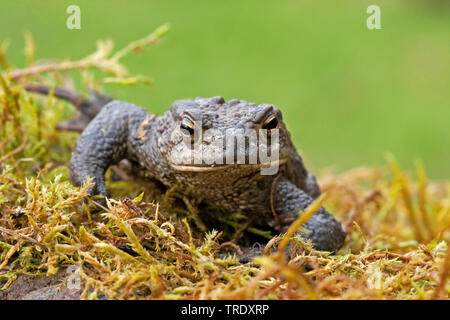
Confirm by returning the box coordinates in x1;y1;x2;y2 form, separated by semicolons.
0;30;450;299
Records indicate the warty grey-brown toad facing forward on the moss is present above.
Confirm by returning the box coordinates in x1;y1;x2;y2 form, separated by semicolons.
70;97;345;252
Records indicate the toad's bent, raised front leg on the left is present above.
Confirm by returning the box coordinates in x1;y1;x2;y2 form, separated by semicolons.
70;101;149;196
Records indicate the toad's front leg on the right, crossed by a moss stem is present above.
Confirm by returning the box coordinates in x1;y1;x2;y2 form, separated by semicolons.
274;178;345;252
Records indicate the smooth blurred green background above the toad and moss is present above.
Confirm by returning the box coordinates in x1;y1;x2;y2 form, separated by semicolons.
0;0;450;179
